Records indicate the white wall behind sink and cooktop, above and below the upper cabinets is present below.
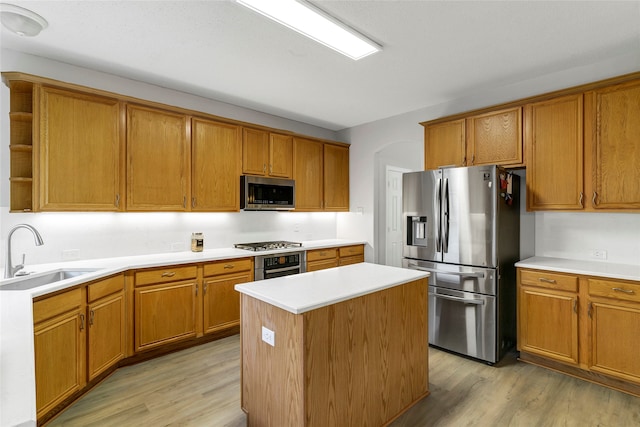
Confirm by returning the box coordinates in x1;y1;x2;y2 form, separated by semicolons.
0;49;338;269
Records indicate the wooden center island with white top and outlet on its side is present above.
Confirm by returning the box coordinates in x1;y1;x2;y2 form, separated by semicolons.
235;263;429;427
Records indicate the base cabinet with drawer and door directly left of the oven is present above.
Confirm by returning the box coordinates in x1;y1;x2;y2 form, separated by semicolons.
203;258;253;334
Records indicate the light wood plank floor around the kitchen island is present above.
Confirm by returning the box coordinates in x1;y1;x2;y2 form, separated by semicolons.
48;335;640;427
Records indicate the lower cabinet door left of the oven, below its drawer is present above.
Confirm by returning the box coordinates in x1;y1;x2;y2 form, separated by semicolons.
204;272;253;334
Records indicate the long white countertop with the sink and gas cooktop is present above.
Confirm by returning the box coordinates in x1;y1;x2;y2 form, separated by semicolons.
0;239;366;427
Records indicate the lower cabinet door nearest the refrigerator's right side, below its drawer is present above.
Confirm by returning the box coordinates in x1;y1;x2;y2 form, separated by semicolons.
518;286;578;365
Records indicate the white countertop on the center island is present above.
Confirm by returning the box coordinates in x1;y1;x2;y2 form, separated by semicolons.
235;263;429;314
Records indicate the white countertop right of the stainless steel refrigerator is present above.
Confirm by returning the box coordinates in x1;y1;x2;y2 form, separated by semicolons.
516;257;640;281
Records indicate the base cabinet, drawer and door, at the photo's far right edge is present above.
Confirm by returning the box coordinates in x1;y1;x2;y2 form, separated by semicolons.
587;278;640;384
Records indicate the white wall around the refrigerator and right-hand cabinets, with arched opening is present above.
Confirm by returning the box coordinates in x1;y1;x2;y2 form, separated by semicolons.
338;52;640;263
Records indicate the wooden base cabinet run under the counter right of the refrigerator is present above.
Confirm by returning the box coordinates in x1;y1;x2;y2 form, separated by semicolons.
518;269;640;396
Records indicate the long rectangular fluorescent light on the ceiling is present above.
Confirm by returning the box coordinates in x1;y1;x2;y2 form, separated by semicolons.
236;0;382;60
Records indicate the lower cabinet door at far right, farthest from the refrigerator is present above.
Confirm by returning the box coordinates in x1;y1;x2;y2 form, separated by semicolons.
588;300;640;383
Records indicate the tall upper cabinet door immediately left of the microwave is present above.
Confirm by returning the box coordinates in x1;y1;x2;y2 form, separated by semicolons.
191;119;242;212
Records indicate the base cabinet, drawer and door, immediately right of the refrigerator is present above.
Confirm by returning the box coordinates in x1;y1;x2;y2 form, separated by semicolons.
518;270;578;365
